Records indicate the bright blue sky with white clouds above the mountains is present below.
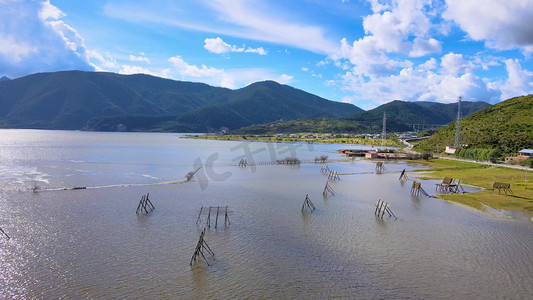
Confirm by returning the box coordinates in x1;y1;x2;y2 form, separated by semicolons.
0;0;533;110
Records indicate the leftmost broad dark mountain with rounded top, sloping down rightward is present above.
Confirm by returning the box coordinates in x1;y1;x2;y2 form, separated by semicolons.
0;72;164;129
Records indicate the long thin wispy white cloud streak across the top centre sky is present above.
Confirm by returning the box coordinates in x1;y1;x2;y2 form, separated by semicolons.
104;0;337;54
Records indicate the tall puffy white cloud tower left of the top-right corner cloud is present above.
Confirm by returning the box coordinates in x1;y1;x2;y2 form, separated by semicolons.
331;0;441;77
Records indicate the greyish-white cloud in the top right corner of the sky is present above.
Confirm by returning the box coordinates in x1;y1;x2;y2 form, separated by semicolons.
443;0;533;52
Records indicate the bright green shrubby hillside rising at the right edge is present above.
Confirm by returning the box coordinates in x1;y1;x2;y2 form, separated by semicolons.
415;95;533;154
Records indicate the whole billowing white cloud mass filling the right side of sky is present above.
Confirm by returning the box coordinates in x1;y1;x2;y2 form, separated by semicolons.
330;0;533;106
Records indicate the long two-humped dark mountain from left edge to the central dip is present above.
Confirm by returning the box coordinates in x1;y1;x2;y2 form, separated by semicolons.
0;71;362;132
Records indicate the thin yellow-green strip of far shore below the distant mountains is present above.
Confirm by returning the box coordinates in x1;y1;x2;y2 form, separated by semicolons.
183;135;403;147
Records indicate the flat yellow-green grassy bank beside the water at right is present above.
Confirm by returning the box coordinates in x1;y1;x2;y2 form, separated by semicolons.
420;159;533;215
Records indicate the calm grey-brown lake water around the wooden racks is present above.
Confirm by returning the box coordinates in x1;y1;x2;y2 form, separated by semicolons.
0;130;533;299
